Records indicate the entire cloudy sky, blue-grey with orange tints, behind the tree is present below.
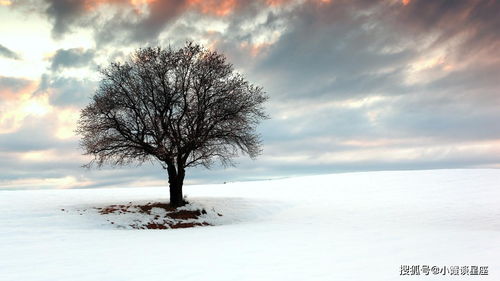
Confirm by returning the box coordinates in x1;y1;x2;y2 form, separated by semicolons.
0;0;500;189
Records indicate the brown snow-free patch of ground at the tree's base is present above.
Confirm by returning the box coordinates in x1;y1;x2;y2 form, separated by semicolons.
96;202;216;229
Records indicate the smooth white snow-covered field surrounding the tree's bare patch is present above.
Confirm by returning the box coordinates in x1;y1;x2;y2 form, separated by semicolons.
0;170;500;281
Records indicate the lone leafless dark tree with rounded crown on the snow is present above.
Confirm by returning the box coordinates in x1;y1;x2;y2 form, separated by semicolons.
77;43;268;207
